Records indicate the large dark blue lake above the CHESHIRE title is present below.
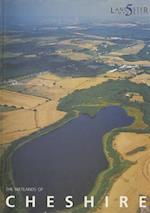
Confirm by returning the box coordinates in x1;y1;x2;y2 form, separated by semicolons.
12;106;133;213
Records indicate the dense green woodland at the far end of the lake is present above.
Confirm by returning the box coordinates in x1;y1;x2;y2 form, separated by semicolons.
58;80;150;124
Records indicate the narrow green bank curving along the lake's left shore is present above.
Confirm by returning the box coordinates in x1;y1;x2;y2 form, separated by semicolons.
0;111;79;213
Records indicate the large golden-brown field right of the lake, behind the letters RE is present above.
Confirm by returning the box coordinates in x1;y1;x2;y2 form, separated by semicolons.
97;132;150;213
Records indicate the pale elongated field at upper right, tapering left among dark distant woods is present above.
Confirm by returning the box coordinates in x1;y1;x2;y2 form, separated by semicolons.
109;41;145;56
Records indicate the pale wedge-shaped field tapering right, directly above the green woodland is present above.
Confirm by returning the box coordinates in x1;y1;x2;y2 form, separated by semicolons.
27;73;108;101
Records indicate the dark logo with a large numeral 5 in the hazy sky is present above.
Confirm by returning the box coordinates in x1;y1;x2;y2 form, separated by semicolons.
110;4;150;16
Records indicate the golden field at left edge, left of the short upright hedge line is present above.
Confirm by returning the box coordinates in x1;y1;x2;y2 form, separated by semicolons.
0;109;39;144
